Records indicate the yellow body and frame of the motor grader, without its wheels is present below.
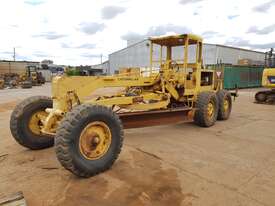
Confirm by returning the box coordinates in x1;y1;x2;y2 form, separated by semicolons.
42;34;220;134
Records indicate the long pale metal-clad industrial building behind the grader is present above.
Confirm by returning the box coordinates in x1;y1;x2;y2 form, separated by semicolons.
107;39;265;74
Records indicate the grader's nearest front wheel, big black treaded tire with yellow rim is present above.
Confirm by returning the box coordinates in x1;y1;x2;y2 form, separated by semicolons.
55;104;123;177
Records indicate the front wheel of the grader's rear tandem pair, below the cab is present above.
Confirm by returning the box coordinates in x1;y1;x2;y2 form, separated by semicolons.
194;92;218;127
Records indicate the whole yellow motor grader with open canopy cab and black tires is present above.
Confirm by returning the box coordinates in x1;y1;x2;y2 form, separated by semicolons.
10;34;232;177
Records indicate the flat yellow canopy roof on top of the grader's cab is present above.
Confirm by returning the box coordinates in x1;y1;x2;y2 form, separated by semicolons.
149;34;202;46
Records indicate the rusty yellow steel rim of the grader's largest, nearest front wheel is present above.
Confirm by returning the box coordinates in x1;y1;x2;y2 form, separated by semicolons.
79;121;112;160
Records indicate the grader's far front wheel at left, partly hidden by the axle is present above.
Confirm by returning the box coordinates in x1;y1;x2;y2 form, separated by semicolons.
10;96;54;150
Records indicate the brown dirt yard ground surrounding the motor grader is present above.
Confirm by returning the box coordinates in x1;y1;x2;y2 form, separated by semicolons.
0;84;275;206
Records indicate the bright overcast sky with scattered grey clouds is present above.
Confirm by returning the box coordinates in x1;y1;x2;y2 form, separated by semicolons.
0;0;275;65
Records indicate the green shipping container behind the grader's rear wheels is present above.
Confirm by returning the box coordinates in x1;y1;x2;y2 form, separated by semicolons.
223;65;264;89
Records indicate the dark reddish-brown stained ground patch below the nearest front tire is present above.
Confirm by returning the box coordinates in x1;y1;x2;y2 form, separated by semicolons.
54;151;198;206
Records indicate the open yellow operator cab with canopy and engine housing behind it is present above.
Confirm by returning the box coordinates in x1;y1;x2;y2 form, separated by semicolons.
150;34;217;92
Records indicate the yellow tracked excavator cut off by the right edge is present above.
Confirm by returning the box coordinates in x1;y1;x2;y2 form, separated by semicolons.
255;49;275;104
